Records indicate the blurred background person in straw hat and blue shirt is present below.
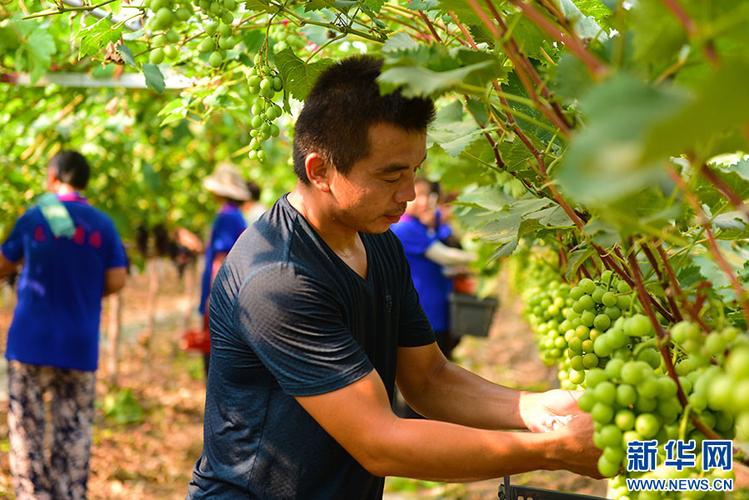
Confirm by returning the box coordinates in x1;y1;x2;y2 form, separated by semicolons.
199;164;250;378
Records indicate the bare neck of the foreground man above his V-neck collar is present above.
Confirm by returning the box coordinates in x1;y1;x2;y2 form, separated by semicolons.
288;184;360;254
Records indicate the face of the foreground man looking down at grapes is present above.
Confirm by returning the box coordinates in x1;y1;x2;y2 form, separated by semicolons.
330;123;426;233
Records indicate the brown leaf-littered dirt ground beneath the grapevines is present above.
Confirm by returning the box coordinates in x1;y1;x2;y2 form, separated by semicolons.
0;265;606;500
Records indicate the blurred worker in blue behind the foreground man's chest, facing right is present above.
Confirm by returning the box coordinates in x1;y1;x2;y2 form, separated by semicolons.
390;178;475;359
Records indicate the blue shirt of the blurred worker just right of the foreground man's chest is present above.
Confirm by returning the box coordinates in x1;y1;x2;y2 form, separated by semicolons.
391;215;453;333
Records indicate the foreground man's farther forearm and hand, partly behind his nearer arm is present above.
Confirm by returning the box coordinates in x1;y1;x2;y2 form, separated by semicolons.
397;343;581;431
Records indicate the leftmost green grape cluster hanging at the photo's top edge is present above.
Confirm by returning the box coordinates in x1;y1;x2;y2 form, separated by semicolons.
144;0;193;64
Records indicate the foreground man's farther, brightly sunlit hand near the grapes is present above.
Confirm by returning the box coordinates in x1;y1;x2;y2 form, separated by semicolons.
518;389;589;432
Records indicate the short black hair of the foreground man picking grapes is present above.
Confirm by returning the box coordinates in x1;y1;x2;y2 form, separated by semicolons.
294;56;434;183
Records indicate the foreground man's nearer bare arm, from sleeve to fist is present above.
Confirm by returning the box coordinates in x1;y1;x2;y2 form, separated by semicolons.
296;370;597;482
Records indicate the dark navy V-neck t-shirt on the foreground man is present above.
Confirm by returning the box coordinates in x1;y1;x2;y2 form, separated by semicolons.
187;197;434;499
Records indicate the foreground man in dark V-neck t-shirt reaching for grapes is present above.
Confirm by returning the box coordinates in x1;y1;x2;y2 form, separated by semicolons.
187;56;599;500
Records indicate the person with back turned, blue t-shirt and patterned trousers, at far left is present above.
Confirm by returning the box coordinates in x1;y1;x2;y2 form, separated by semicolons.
0;151;127;499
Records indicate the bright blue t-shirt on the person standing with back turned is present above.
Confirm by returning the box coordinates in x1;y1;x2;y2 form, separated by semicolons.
1;191;126;371
